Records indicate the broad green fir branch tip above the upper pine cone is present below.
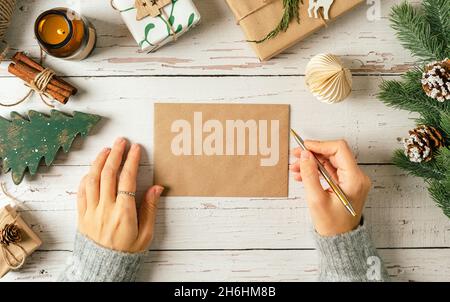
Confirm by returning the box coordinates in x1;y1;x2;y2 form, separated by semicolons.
390;0;447;61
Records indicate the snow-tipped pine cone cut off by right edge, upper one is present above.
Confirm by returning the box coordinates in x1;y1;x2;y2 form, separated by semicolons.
422;59;450;102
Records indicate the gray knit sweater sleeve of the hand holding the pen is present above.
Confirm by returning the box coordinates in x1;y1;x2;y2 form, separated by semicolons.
315;225;389;282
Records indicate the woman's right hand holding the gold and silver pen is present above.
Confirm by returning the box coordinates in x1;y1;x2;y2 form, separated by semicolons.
290;140;371;236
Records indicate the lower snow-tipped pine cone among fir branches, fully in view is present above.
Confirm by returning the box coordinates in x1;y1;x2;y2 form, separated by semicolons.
403;125;444;163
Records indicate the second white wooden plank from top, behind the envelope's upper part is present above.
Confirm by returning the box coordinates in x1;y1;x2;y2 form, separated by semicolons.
0;76;414;165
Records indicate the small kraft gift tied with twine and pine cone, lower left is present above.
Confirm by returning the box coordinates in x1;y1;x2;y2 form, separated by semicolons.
0;205;42;278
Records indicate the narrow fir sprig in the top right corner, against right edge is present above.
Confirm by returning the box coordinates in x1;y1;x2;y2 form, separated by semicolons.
423;0;450;59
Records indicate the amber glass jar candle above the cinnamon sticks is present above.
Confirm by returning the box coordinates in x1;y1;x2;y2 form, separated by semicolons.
34;7;96;60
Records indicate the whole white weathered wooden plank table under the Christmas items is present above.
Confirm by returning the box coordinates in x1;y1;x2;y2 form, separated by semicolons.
0;0;450;281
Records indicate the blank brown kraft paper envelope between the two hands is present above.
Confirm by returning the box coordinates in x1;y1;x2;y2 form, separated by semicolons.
154;104;289;197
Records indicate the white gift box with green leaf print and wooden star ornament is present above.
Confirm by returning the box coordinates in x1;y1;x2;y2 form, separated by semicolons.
111;0;200;51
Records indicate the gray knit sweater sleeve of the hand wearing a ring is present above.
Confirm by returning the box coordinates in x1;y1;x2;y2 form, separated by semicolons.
58;233;144;282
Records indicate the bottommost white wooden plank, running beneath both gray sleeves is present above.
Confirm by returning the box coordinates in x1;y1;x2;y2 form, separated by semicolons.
4;249;450;282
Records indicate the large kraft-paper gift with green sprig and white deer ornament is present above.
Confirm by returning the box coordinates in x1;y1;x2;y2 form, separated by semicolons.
226;0;364;61
